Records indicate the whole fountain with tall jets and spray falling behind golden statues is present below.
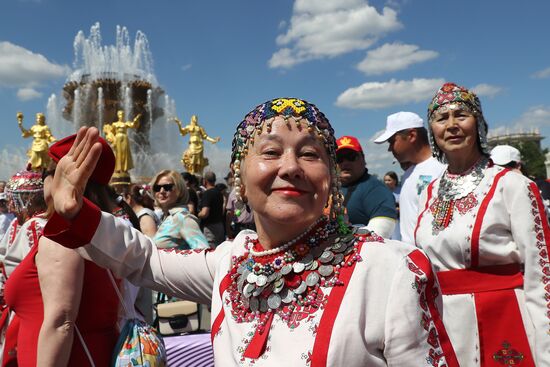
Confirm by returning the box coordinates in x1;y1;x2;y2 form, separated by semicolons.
47;23;181;182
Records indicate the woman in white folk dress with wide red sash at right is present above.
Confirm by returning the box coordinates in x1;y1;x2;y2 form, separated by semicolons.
415;83;550;366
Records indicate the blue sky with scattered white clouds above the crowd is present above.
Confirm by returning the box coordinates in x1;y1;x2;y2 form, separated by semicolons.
0;0;550;178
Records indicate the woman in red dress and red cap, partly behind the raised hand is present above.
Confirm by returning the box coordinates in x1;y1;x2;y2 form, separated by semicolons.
5;135;120;367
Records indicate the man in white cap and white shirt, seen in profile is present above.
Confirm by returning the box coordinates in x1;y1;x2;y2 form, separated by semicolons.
374;112;445;243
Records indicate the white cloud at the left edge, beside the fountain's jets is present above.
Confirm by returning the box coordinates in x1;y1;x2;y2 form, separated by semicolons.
0;42;69;87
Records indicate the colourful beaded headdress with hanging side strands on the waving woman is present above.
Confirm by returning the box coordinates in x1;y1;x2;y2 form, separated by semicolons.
231;98;349;233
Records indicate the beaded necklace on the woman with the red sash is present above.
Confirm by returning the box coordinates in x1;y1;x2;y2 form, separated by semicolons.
431;156;489;233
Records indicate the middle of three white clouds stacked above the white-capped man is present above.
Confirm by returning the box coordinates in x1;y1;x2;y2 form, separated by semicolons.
357;43;439;75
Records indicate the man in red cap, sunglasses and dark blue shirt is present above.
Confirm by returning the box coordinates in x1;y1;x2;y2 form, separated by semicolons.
336;136;397;238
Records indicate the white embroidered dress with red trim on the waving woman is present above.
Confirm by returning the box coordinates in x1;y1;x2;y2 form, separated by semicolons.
45;203;456;367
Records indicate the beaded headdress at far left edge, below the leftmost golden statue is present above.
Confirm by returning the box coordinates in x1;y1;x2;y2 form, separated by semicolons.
6;170;44;211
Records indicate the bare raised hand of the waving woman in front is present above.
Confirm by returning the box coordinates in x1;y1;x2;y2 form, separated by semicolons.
51;127;102;220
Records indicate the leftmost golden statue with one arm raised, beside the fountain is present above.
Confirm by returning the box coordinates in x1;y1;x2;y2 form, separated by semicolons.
17;112;55;171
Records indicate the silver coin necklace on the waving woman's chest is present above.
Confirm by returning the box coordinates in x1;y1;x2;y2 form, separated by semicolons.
228;217;370;334
